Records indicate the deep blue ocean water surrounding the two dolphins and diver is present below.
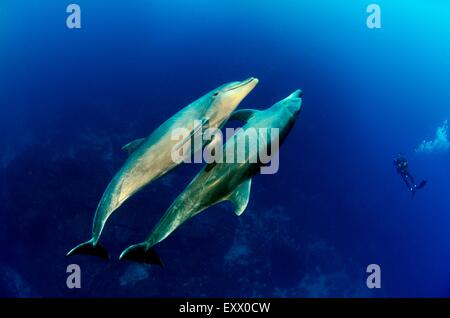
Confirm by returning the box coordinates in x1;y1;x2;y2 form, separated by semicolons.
0;0;450;297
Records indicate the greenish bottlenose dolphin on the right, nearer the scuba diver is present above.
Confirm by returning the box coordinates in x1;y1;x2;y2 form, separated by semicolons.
120;90;302;266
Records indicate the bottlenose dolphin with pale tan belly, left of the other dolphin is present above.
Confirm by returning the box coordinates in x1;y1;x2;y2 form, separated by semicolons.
67;77;258;259
